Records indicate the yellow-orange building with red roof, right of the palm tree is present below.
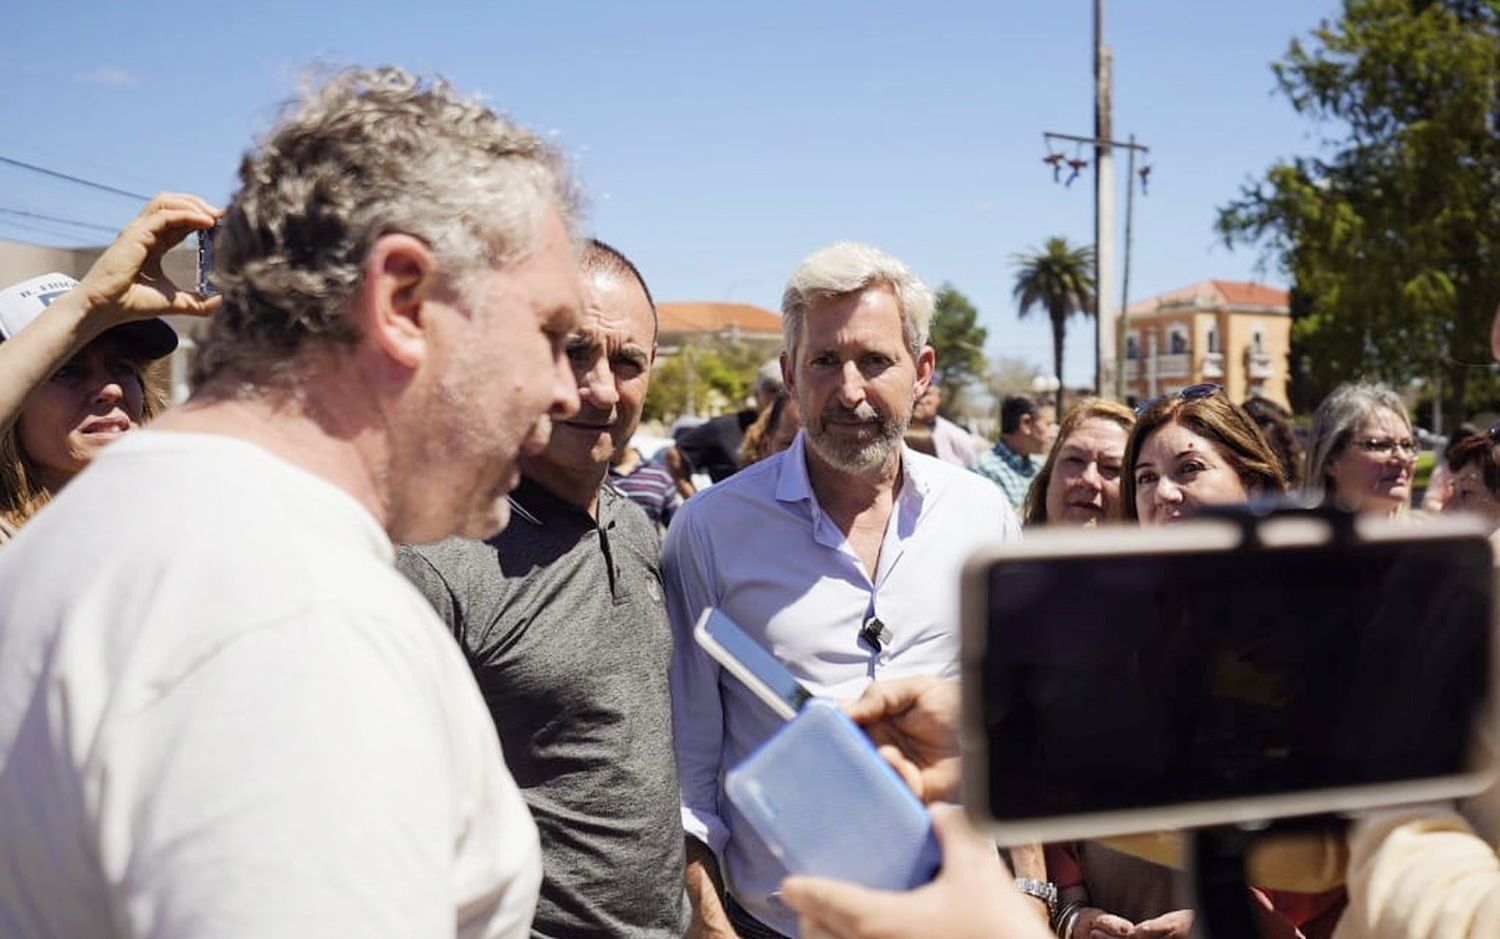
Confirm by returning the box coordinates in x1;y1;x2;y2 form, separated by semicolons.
1125;281;1292;407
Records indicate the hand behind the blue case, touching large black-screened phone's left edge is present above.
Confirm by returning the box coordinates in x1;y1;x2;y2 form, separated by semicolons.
843;675;959;803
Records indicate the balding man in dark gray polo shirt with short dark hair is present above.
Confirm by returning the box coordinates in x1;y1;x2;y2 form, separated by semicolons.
399;242;689;938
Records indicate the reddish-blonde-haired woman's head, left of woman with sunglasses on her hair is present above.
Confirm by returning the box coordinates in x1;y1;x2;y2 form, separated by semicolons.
1022;398;1136;528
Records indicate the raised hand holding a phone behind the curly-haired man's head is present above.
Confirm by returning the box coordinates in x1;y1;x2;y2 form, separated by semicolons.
78;192;224;332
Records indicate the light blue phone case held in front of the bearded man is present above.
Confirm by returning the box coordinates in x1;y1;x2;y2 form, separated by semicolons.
725;699;942;890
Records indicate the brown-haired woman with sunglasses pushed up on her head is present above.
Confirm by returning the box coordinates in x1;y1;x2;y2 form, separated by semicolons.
1122;384;1286;525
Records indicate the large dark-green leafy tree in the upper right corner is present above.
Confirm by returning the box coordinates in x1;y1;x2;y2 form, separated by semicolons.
1218;0;1500;410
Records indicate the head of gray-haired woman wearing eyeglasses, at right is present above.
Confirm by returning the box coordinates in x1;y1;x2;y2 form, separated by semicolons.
1304;383;1418;516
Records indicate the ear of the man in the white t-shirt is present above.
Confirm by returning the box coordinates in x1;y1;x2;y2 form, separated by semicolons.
362;233;438;369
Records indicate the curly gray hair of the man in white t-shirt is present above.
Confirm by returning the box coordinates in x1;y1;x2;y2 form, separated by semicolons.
195;68;578;384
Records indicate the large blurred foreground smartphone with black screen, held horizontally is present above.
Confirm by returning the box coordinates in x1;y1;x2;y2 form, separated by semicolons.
962;515;1496;843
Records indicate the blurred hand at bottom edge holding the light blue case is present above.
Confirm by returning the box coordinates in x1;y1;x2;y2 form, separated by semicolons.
782;806;1055;939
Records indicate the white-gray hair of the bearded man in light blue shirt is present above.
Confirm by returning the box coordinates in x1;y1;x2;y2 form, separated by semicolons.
782;242;933;363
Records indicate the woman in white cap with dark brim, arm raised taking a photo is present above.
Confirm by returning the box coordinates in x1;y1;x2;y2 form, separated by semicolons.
0;194;219;543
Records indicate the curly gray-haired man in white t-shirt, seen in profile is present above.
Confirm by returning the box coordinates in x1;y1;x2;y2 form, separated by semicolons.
0;69;581;939
